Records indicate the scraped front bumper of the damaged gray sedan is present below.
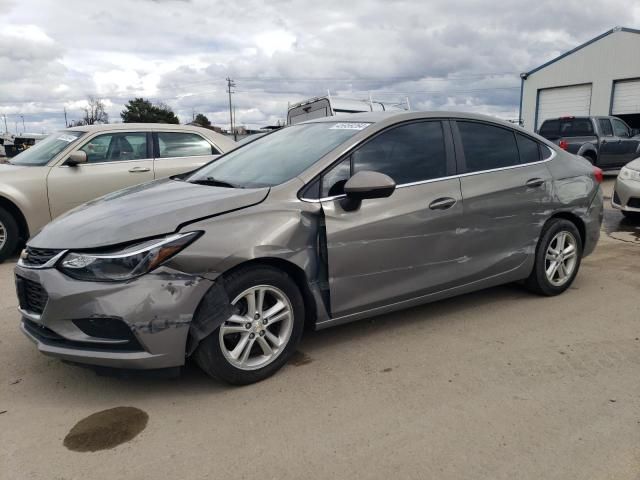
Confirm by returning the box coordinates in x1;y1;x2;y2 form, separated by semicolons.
15;265;213;369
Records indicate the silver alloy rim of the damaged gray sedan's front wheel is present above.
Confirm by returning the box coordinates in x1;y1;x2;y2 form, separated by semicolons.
219;285;293;370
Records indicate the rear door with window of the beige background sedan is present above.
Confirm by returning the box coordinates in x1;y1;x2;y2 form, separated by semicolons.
153;131;220;178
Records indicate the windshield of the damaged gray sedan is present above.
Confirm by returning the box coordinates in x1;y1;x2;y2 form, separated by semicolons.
186;122;370;188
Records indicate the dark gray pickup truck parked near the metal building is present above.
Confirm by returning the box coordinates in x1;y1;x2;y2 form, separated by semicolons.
538;117;640;169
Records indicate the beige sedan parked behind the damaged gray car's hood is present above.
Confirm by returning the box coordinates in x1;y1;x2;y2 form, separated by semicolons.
0;123;236;261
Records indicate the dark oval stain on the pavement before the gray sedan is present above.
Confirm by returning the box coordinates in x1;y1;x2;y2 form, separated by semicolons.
63;407;149;452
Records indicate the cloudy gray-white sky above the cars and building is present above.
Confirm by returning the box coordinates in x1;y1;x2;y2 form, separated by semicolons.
0;0;640;132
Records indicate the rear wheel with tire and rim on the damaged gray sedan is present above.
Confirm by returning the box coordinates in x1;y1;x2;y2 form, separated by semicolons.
525;218;582;296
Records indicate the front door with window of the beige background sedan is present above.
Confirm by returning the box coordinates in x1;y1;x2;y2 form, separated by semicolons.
47;131;154;217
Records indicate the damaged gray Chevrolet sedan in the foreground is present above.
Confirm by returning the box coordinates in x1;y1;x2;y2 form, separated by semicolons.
15;112;603;384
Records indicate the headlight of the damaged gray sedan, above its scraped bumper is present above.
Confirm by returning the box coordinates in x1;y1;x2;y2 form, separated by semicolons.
58;232;201;282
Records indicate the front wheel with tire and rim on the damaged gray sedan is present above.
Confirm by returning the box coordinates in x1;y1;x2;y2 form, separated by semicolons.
195;266;305;385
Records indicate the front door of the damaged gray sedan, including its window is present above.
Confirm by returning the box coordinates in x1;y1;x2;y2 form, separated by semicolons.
321;121;462;318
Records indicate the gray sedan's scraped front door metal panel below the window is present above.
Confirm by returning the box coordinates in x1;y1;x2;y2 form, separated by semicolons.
323;178;464;316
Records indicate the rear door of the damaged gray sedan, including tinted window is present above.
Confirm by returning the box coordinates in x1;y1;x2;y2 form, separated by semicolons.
454;120;552;282
